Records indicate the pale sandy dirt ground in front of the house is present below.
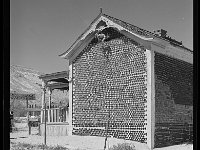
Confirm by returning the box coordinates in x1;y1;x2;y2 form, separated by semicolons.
10;123;193;150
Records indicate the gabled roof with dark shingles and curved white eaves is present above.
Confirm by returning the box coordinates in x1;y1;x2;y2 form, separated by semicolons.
59;12;193;63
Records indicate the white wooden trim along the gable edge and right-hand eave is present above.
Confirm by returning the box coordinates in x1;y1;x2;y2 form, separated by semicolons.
60;13;193;63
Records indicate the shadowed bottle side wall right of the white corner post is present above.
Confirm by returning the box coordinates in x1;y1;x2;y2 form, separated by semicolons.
155;53;193;147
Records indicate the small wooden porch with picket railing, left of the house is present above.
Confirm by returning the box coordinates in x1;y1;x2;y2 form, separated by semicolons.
39;71;69;136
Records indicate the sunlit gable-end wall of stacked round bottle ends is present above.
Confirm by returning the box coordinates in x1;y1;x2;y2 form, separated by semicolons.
72;33;147;142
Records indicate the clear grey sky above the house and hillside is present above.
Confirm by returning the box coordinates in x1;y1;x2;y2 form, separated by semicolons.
10;0;193;73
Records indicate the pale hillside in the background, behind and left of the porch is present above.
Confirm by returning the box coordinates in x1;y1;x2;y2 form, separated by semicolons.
10;65;68;116
